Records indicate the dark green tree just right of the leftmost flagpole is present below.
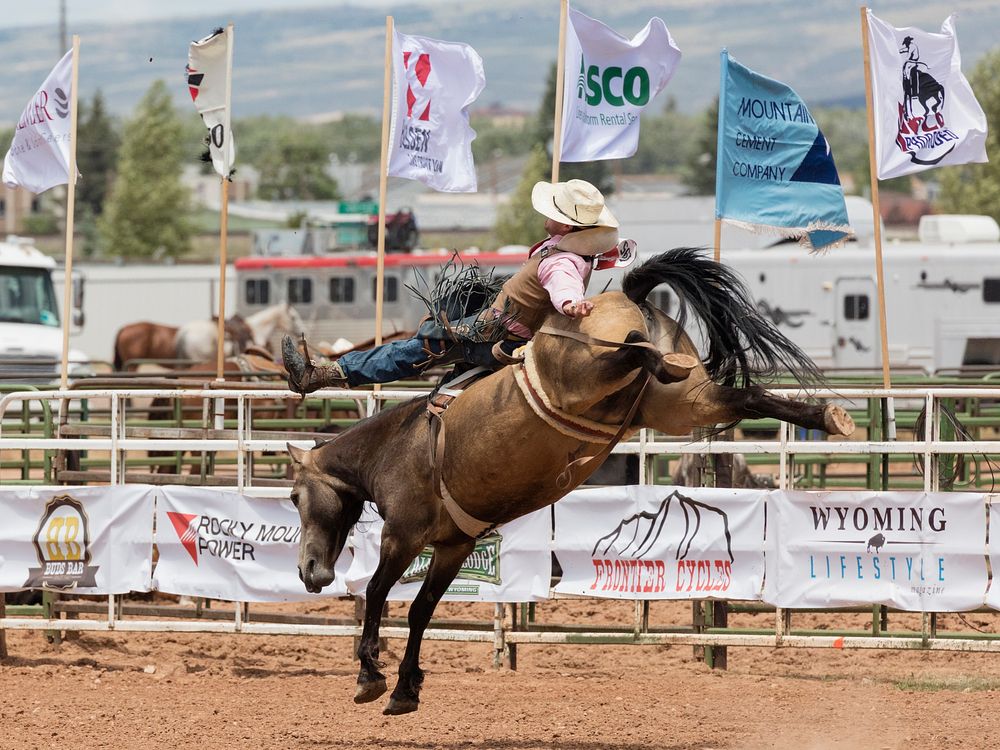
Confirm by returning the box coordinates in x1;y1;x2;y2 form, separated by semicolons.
76;89;121;216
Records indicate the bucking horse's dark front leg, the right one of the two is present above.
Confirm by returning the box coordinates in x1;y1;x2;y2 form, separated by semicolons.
382;539;476;715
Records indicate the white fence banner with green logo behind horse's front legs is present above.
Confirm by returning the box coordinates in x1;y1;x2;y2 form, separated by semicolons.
347;505;552;602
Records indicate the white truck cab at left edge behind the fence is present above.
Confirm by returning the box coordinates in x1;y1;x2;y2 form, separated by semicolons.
0;235;87;383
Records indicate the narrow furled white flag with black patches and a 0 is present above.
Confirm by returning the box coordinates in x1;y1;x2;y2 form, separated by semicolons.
186;25;236;178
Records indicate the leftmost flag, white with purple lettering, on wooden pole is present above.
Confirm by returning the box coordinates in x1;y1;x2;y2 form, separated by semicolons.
3;50;73;193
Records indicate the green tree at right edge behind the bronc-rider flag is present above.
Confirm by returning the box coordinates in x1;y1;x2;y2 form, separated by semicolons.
938;48;1000;221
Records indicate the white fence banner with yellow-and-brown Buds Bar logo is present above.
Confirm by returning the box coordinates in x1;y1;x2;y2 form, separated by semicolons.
0;485;153;594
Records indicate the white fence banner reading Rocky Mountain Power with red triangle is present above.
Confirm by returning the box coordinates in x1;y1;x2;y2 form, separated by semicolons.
153;487;351;602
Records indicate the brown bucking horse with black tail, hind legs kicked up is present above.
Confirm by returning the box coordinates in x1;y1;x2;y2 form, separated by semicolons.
288;248;854;714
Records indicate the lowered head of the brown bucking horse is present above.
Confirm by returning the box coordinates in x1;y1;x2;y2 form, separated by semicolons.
288;443;364;594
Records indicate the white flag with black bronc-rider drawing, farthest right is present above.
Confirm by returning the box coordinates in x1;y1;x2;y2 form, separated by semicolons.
868;10;987;180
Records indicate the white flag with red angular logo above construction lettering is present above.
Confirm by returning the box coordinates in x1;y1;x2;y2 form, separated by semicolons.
388;30;486;193
